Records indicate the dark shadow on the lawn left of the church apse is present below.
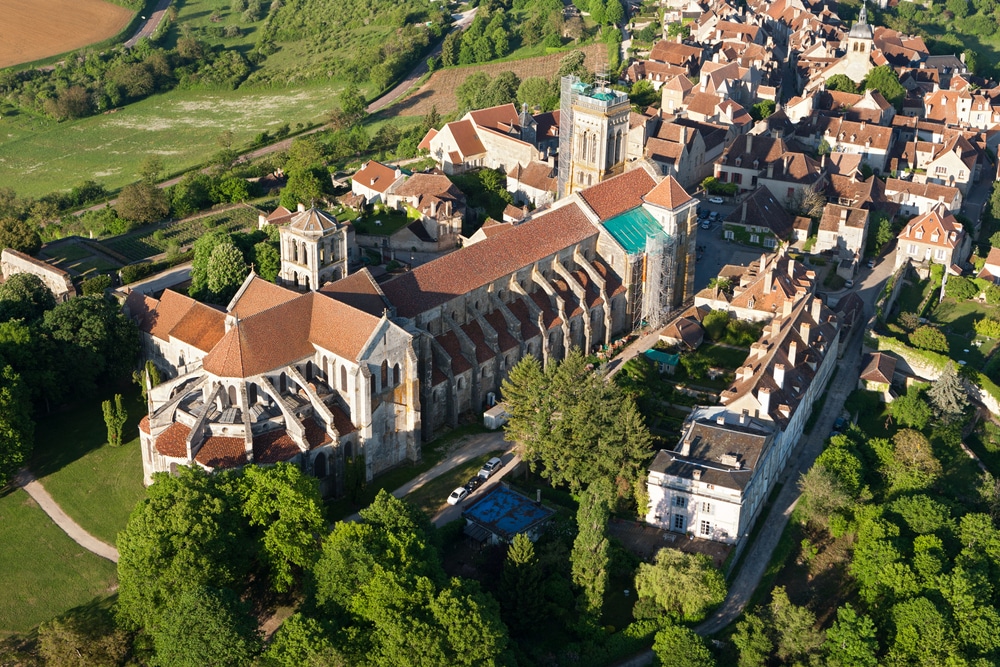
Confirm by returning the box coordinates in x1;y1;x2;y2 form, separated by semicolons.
30;385;146;479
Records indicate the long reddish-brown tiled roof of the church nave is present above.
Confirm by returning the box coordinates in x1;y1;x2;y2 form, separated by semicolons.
382;202;596;317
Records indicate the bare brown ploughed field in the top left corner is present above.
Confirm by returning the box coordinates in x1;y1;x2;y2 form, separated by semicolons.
0;0;132;67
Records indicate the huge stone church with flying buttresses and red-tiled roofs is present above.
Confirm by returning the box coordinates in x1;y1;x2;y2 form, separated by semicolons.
126;171;696;494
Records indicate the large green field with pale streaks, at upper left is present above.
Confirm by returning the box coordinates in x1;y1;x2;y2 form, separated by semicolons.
0;81;341;197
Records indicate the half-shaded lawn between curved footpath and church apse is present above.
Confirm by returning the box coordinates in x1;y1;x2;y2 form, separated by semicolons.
31;392;145;544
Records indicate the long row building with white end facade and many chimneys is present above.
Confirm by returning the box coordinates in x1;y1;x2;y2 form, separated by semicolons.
646;294;839;544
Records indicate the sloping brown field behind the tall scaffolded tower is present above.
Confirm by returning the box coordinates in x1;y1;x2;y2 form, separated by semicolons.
390;44;608;116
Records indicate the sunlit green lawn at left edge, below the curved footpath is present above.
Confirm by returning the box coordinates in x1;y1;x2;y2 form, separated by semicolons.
0;489;117;634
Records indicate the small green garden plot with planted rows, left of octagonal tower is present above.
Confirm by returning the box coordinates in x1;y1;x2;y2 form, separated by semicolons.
101;206;258;262
